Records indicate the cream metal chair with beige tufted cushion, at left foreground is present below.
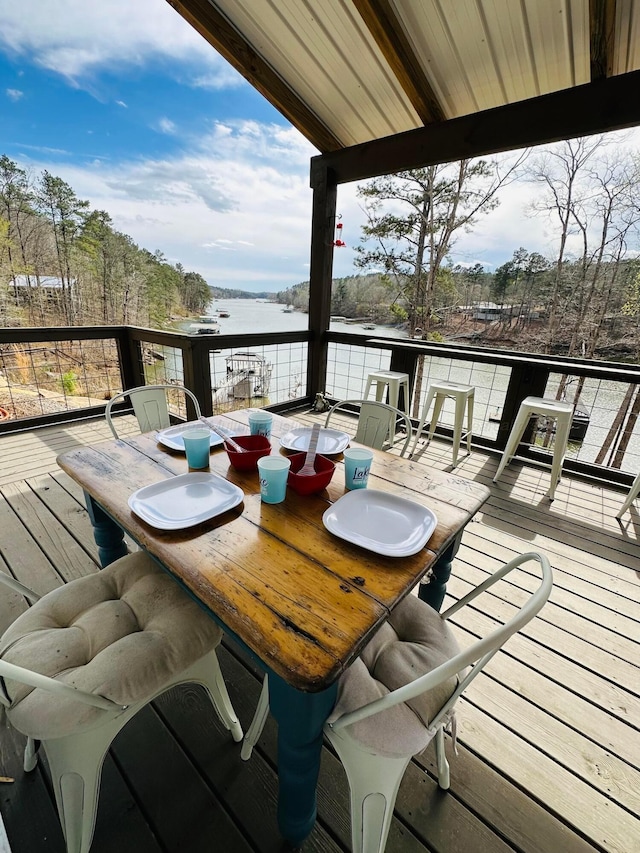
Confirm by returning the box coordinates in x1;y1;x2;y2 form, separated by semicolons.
0;552;242;853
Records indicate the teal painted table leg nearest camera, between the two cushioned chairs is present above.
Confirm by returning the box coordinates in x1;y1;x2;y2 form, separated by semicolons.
269;672;338;847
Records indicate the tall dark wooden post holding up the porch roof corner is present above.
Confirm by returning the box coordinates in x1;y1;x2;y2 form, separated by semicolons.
307;164;337;400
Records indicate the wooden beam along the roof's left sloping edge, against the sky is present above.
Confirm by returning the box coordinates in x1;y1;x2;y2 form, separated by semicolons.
167;0;343;152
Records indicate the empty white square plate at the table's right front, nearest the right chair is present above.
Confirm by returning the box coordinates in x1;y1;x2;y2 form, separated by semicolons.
322;489;438;557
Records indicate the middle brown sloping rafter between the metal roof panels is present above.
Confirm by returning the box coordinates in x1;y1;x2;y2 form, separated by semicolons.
353;0;446;124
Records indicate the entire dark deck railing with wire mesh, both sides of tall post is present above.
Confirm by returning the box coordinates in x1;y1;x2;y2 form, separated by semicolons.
0;326;640;485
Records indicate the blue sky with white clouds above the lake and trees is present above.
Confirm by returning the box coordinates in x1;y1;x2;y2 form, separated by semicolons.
0;0;636;291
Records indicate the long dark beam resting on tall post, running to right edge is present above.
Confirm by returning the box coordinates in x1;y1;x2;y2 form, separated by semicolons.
311;71;640;186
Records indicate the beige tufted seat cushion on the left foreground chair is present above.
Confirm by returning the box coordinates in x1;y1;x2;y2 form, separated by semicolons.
0;551;222;740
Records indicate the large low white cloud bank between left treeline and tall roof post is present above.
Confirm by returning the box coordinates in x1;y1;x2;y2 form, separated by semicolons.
18;121;318;290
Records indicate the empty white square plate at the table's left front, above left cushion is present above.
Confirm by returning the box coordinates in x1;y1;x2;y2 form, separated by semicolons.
129;471;244;530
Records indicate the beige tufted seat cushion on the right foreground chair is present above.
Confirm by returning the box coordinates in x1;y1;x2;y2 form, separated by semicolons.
329;595;460;756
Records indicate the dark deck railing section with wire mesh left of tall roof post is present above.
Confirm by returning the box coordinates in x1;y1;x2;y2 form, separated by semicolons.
0;326;309;433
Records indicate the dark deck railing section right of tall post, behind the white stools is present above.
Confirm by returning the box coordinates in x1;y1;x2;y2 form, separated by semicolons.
325;332;640;485
